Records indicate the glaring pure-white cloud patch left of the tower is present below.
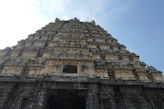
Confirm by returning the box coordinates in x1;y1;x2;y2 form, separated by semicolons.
0;0;43;49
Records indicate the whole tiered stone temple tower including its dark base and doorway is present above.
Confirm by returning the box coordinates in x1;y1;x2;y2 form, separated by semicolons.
0;18;164;109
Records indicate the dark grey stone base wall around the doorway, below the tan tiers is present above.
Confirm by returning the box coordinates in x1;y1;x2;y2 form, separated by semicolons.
0;82;164;109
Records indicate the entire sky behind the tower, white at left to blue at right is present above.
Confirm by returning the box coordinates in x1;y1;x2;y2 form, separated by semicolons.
0;0;164;72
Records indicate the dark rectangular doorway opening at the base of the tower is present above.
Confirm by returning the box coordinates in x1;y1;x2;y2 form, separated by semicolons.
47;90;86;109
